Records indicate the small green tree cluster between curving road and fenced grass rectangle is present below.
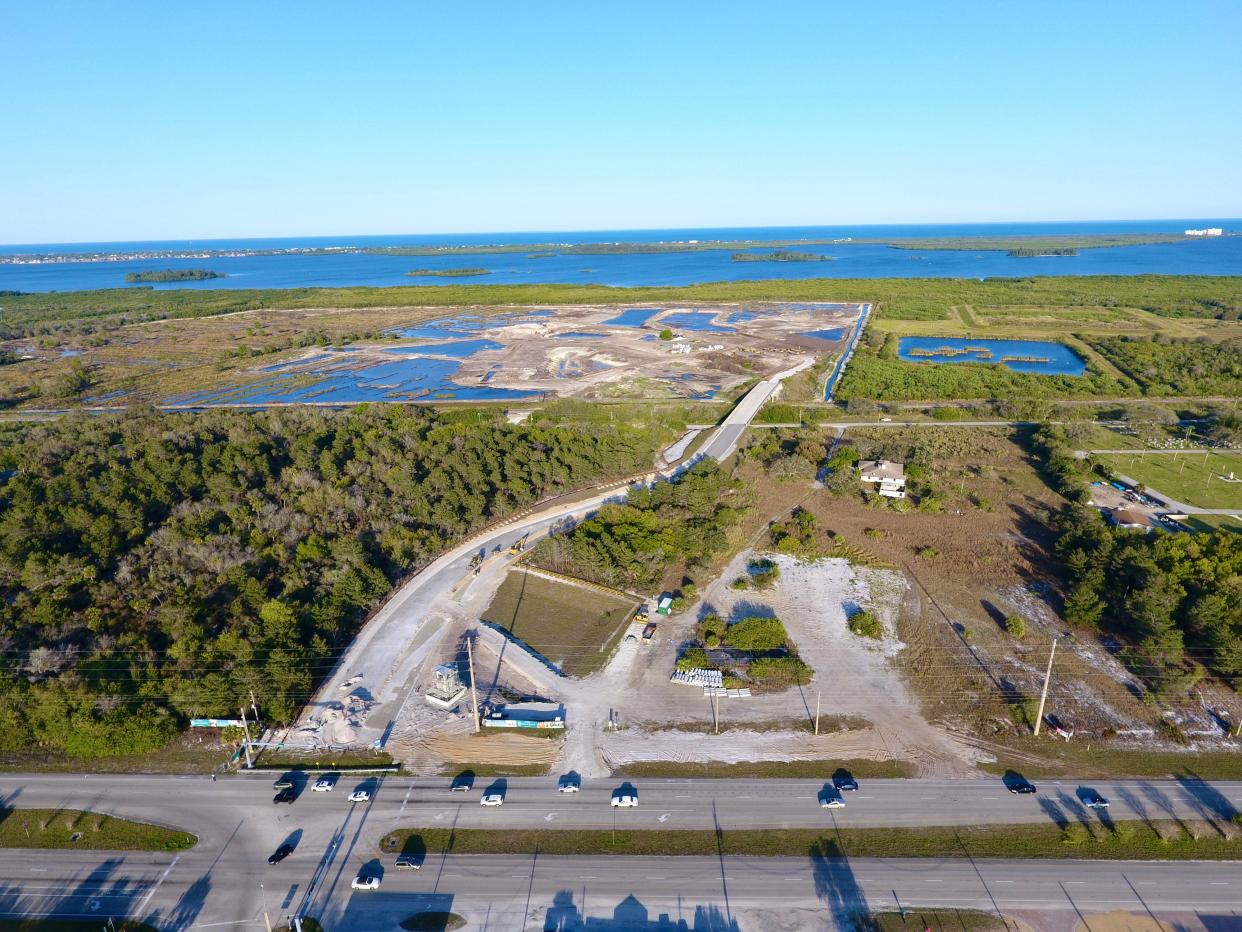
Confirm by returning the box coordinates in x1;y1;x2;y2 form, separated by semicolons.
533;460;744;589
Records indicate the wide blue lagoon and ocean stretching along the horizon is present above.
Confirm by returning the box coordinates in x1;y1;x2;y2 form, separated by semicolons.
0;217;1242;292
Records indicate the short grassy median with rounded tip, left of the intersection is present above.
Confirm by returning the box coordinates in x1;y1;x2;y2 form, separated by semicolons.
0;809;197;854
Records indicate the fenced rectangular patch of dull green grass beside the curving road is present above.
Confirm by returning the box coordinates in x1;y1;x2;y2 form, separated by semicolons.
483;570;638;676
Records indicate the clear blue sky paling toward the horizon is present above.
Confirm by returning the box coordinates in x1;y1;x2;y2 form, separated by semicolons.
0;0;1242;242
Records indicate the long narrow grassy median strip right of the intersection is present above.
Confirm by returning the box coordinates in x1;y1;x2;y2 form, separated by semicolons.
383;814;1242;861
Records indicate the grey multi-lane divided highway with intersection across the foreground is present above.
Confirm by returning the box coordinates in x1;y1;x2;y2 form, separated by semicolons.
0;774;1242;932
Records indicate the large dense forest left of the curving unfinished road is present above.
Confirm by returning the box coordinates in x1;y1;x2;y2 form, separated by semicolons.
0;405;660;757
